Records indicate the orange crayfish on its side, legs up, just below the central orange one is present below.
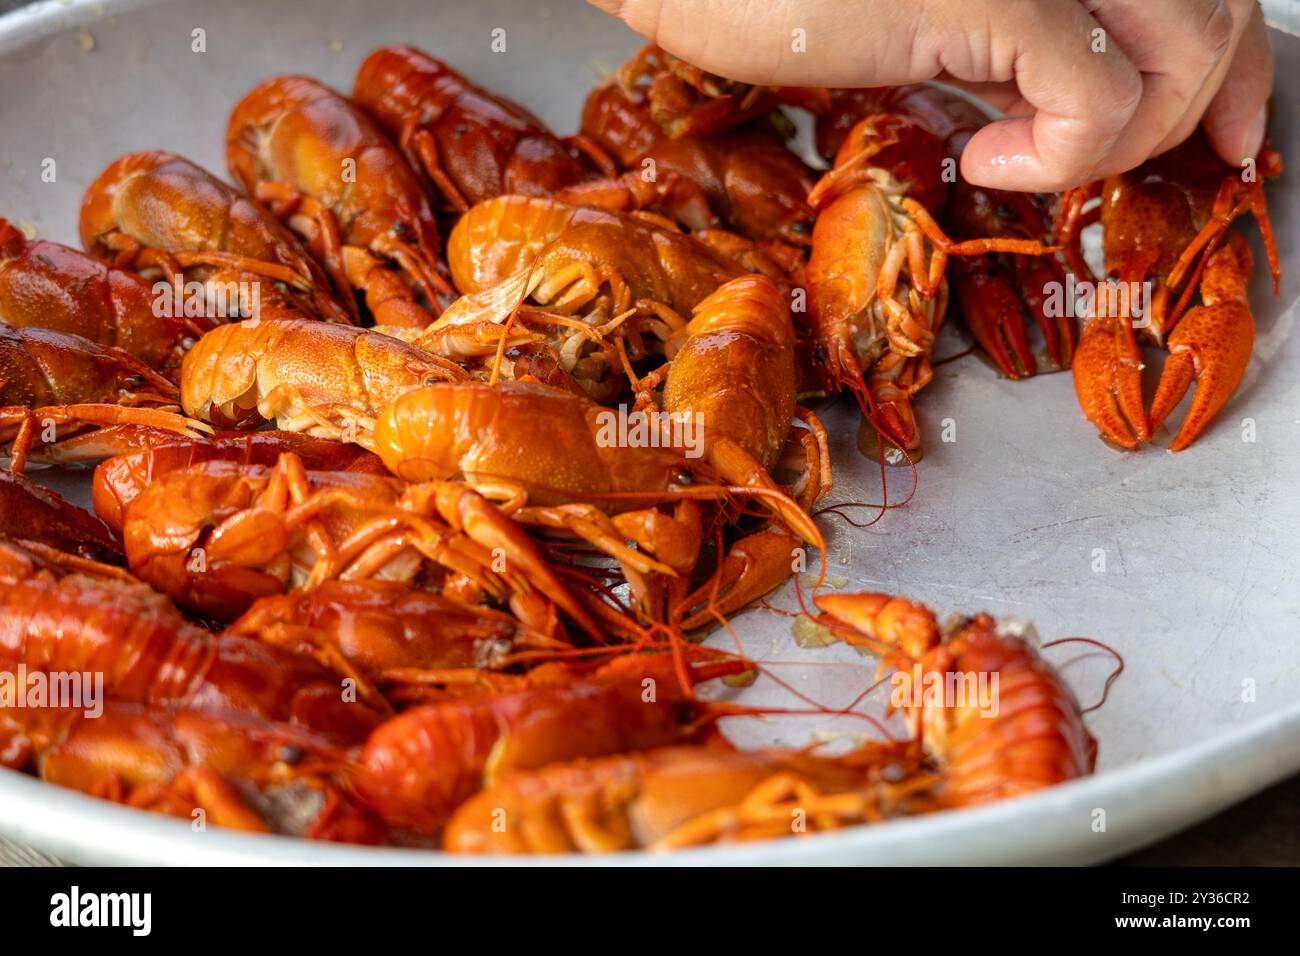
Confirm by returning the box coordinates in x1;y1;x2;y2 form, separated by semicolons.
122;453;601;637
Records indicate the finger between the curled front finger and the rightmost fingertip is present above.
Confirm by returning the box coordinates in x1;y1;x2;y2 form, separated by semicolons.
1086;0;1245;170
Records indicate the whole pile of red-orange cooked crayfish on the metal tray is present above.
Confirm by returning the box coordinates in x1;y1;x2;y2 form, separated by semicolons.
0;37;1281;853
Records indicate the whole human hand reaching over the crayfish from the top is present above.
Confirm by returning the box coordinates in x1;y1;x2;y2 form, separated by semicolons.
590;0;1273;191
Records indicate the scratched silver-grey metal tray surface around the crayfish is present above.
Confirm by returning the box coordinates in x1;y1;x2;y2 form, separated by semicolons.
0;0;1300;864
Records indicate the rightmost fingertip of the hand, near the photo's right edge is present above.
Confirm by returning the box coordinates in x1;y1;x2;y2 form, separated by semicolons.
1205;7;1273;166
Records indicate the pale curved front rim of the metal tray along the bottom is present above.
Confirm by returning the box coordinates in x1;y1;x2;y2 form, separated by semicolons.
0;705;1300;866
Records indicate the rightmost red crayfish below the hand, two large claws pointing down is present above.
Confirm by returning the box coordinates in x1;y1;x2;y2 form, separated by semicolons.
1058;130;1282;451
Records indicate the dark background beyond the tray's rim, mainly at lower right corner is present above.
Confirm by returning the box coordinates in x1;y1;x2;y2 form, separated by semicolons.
0;0;1300;866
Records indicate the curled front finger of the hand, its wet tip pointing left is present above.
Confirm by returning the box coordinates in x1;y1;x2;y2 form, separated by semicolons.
945;3;1143;191
